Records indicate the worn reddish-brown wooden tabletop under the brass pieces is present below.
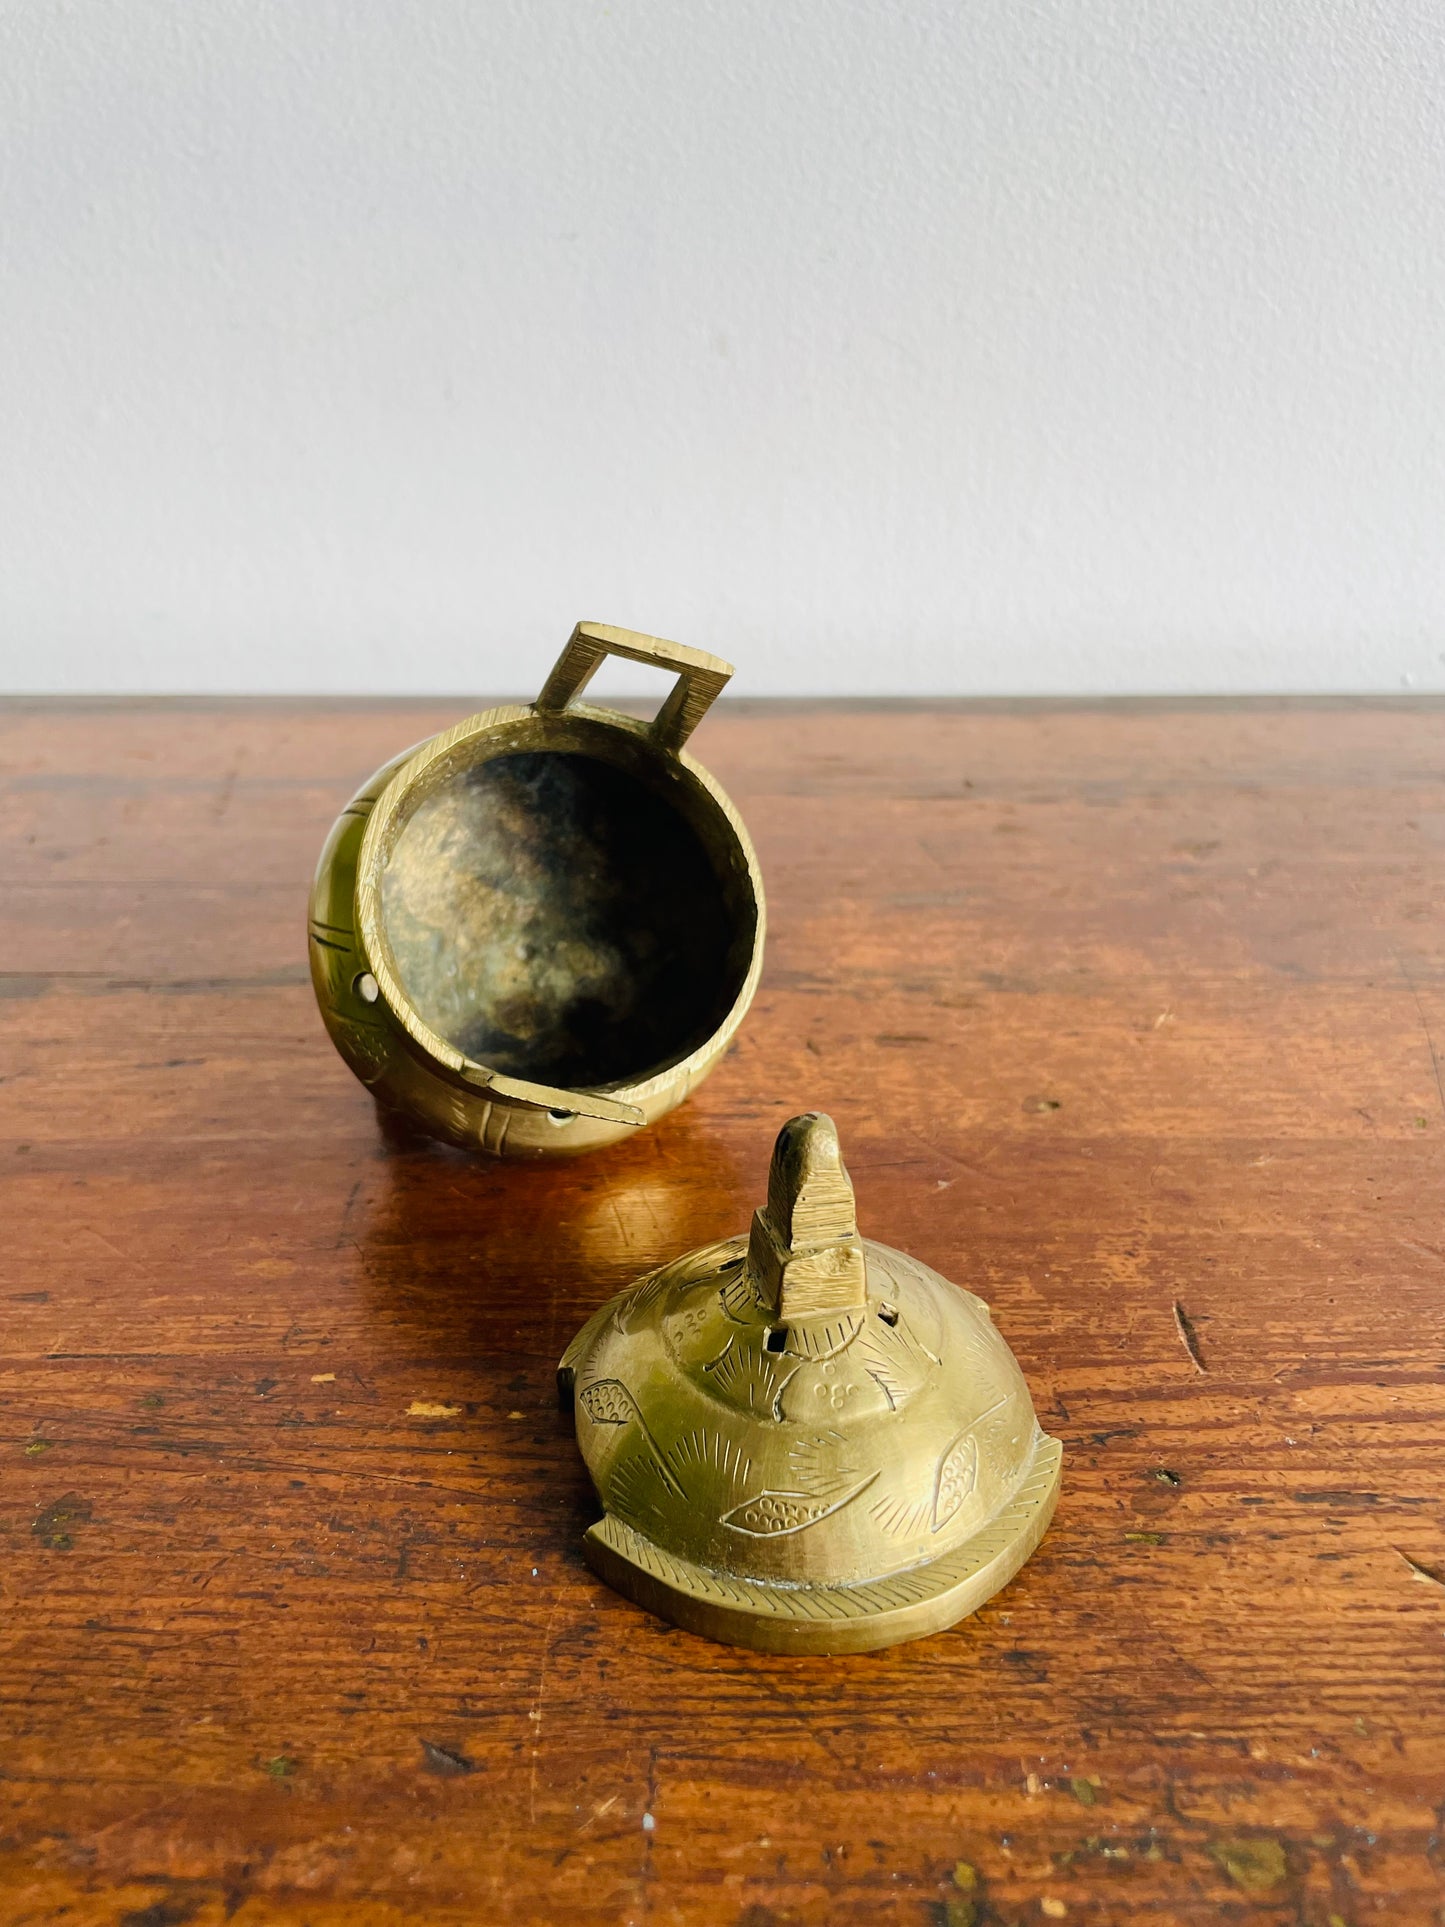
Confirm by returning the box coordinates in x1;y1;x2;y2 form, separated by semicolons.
0;703;1445;1927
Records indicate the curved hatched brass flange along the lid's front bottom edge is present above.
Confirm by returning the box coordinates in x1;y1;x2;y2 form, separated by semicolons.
584;1432;1064;1653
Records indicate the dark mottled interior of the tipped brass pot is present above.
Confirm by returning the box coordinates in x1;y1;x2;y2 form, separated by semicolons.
381;750;755;1089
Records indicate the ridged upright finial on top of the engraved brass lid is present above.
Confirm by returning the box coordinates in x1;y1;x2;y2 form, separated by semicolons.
748;1110;867;1322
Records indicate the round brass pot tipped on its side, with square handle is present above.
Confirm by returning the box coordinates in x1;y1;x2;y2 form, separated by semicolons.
310;622;765;1156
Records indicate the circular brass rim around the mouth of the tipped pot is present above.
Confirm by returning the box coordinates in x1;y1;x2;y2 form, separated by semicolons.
356;701;767;1123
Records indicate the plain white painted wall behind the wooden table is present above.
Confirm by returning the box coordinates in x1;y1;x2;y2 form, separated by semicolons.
0;0;1445;692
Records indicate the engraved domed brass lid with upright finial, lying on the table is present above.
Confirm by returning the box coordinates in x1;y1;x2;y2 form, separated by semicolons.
559;1114;1062;1653
